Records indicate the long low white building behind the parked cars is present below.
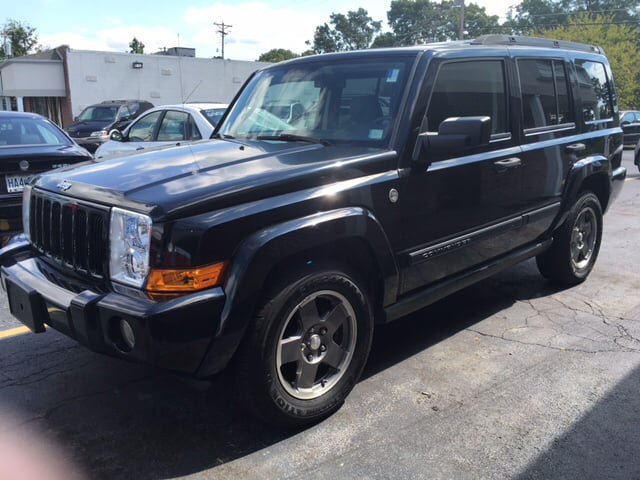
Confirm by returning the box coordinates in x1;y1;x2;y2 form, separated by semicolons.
0;46;268;127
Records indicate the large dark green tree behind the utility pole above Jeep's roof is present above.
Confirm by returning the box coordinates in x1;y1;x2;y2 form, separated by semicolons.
383;0;500;45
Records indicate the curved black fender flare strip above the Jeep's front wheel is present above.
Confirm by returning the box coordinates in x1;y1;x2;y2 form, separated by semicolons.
198;207;399;376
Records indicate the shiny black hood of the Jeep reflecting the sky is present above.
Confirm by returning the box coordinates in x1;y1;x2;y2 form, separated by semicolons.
36;140;396;219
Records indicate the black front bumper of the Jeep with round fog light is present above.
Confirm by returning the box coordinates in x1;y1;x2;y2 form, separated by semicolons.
0;243;237;375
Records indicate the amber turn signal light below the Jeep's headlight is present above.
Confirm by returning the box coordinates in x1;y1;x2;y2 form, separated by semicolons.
147;262;227;293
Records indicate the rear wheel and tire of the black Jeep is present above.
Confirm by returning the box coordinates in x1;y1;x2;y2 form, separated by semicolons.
536;192;602;285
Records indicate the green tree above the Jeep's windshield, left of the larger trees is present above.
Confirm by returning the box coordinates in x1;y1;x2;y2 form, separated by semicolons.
307;8;382;53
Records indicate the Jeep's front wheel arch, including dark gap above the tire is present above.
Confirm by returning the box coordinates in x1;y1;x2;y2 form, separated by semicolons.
199;207;398;375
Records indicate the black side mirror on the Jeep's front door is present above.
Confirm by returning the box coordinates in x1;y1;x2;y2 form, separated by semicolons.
418;116;491;164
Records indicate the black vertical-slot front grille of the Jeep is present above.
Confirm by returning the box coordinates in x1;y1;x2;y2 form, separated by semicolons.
29;190;109;278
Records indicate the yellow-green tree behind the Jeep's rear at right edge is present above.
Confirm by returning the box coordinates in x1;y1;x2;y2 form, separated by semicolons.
541;13;640;110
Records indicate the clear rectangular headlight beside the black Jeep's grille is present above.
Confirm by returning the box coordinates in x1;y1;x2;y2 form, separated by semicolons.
109;207;152;288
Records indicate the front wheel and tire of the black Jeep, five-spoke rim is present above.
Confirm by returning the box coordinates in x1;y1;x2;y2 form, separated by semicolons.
237;269;373;426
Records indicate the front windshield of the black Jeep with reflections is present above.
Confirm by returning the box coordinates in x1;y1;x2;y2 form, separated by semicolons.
218;56;414;146
